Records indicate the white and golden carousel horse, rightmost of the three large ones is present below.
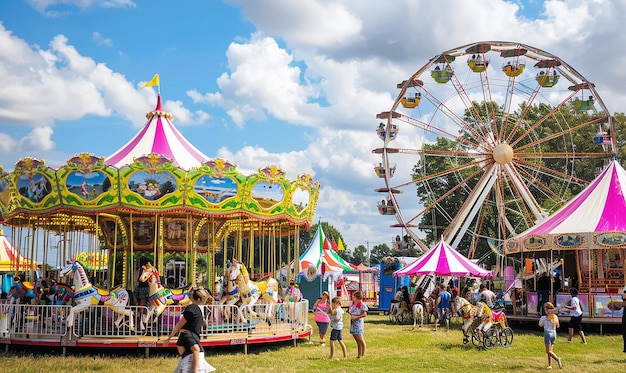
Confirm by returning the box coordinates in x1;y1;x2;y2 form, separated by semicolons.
226;259;279;324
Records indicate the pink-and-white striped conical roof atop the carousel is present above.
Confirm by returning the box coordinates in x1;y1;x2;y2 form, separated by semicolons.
105;96;209;170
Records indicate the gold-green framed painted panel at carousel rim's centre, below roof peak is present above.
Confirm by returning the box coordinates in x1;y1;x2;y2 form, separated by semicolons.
120;154;186;211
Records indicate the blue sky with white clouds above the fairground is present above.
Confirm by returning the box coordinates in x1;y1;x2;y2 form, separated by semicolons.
0;0;626;253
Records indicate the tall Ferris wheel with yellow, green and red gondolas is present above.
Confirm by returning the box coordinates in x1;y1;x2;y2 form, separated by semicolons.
373;42;614;256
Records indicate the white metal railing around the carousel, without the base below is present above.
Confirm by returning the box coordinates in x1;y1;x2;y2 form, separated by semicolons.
0;300;308;339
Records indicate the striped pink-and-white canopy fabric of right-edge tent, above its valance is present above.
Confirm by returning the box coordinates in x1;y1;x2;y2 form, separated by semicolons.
518;161;626;237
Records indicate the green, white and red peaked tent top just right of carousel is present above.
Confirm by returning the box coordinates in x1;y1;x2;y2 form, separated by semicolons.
299;224;357;280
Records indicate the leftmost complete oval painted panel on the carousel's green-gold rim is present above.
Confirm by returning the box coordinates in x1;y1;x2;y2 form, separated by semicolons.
11;157;61;212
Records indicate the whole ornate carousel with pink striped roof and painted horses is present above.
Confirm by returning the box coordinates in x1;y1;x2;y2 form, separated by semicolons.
0;94;320;353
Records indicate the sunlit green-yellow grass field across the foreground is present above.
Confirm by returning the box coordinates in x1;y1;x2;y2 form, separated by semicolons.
0;315;626;373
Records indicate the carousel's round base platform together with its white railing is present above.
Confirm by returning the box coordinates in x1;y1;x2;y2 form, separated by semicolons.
0;301;312;356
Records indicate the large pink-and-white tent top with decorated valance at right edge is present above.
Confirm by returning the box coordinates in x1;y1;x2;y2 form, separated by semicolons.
505;161;626;253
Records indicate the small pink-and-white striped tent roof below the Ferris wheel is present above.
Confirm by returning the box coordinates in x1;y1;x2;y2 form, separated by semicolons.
393;240;493;277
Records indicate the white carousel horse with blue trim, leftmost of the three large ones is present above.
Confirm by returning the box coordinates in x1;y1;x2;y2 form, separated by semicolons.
59;261;135;331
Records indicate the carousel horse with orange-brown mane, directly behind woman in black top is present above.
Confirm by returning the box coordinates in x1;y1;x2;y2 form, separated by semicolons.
139;263;191;323
